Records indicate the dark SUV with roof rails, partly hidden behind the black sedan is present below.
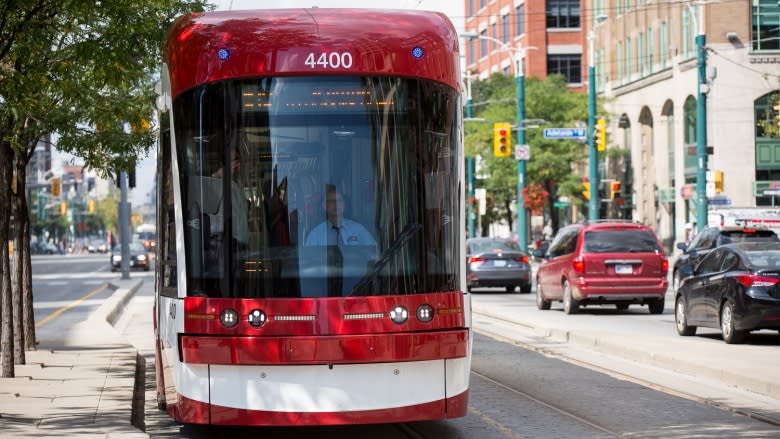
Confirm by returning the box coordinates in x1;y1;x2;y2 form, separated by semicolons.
672;226;780;291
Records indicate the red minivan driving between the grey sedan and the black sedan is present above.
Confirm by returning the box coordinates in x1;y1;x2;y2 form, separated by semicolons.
536;220;669;314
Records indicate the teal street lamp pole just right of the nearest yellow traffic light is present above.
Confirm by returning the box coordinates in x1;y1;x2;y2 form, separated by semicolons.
460;32;528;252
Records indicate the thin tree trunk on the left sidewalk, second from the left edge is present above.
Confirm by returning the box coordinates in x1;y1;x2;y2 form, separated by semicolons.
11;163;27;364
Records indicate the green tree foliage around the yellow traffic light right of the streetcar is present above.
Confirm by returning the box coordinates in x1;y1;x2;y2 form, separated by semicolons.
464;74;588;224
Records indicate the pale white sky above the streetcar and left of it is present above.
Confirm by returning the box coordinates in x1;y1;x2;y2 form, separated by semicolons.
52;0;464;207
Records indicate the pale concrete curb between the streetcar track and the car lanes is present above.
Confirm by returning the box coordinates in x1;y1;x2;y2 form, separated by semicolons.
474;308;780;399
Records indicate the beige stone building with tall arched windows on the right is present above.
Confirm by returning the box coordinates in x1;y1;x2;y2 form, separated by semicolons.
587;0;780;247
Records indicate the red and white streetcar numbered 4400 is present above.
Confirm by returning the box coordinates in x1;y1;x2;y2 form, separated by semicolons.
154;8;472;425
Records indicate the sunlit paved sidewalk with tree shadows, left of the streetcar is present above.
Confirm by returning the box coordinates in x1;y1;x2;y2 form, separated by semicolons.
0;279;149;438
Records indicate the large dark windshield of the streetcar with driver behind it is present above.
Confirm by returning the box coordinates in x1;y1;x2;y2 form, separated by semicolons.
173;76;462;298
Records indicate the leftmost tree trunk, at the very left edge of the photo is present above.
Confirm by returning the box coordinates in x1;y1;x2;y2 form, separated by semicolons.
0;142;14;378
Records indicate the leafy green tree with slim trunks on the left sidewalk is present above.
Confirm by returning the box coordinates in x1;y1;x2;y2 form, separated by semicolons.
0;0;210;377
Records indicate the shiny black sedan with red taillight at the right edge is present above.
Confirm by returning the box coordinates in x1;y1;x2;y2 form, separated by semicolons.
674;242;780;344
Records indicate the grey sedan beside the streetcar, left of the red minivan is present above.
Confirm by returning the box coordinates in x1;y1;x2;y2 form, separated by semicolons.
466;238;531;293
